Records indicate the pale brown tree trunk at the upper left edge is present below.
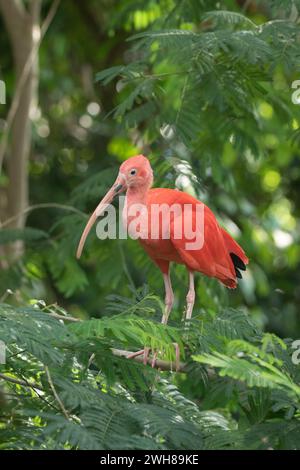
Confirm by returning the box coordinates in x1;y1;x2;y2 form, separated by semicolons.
0;0;41;257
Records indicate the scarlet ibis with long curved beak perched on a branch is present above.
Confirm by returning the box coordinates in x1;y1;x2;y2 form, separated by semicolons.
77;155;248;364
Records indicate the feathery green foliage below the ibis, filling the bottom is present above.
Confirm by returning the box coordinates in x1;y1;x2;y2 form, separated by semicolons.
0;295;300;449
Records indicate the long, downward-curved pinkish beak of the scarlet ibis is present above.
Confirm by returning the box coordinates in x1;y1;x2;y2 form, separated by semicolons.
76;174;126;259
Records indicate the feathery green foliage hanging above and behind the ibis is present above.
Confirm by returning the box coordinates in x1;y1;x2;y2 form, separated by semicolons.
97;1;300;183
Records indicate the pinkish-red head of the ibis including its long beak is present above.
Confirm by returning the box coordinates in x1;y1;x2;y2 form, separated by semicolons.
76;155;153;258
